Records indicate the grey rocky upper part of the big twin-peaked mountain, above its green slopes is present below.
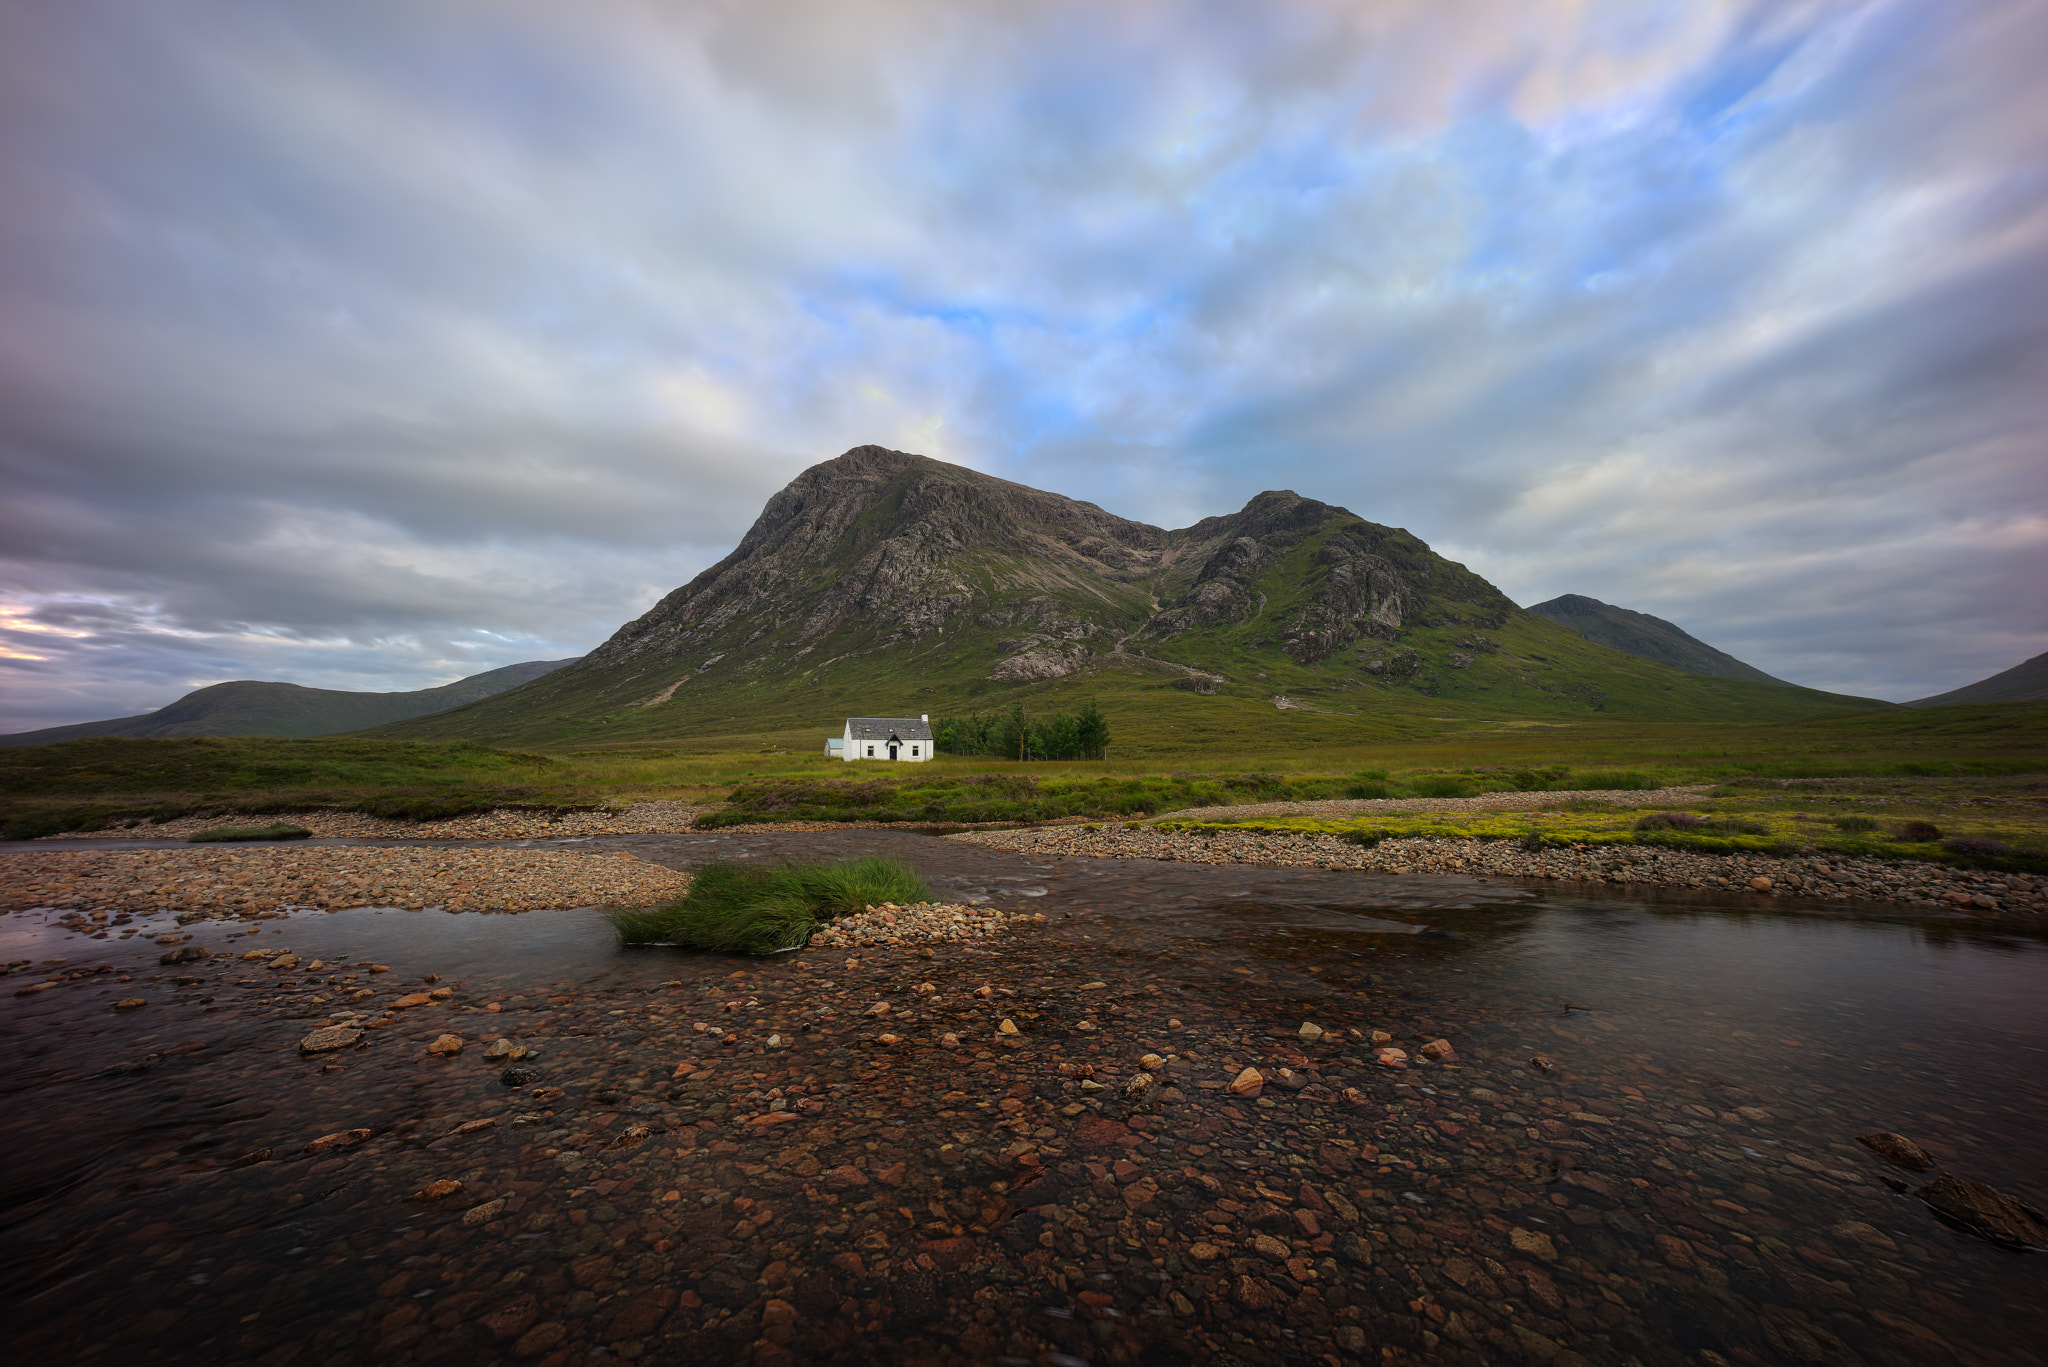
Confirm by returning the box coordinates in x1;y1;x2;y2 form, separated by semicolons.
584;445;1513;691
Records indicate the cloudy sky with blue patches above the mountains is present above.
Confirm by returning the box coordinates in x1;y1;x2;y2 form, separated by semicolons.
0;0;2048;730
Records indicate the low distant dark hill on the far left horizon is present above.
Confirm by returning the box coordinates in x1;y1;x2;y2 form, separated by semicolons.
0;658;575;746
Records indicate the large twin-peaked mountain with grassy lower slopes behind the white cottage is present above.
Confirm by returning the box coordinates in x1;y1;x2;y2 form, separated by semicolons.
375;447;1888;754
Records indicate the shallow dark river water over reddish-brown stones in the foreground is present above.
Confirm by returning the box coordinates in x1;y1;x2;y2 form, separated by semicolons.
0;832;2048;1367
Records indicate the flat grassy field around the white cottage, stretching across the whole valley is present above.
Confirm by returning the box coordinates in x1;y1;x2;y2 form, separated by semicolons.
0;695;2048;838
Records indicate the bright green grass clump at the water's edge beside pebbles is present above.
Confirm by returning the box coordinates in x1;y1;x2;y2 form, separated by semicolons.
606;859;932;955
